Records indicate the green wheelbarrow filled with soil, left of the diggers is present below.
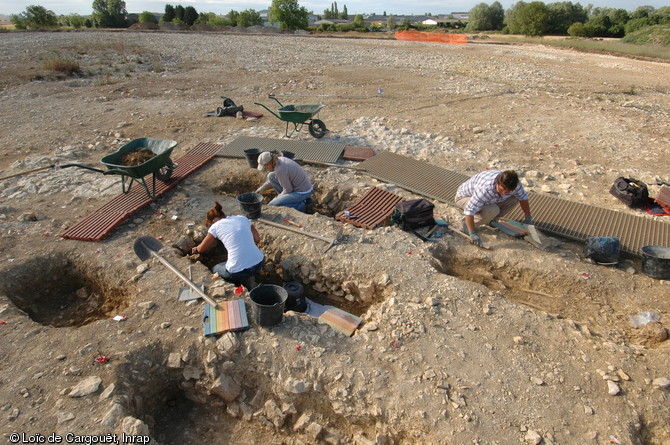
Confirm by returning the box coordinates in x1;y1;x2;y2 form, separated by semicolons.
57;138;178;199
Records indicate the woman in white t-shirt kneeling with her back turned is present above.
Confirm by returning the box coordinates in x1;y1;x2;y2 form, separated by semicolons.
191;202;265;288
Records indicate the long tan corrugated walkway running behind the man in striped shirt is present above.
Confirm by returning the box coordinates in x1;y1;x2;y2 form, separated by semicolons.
359;152;670;256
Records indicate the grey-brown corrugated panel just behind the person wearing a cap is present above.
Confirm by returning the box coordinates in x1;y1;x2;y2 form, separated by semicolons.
217;136;345;164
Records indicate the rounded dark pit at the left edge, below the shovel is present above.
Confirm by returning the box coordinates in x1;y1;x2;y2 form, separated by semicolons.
0;254;128;327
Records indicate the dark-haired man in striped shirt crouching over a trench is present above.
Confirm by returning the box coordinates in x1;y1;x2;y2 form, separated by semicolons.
456;170;533;246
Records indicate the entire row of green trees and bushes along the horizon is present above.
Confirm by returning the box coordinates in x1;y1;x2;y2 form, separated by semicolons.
10;0;670;37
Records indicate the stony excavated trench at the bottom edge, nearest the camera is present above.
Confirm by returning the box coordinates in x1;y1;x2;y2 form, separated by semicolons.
117;343;375;445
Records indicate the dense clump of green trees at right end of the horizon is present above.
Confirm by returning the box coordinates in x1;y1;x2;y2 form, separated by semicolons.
465;1;670;37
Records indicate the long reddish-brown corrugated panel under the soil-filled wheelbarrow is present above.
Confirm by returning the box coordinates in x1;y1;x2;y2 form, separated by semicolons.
61;143;221;241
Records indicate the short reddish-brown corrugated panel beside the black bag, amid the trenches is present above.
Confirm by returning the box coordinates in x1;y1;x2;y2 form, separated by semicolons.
335;187;402;230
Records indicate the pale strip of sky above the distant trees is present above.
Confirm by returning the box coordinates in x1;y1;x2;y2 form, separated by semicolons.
0;0;670;15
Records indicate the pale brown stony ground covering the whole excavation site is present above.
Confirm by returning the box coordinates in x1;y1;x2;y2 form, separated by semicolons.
0;31;670;445
